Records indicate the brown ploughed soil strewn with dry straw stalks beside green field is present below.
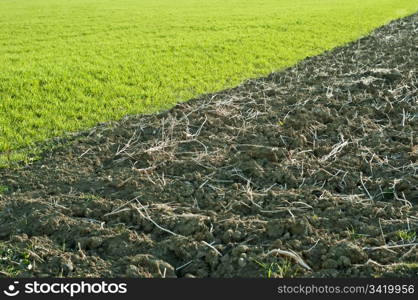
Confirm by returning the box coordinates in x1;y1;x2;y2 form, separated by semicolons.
0;14;418;277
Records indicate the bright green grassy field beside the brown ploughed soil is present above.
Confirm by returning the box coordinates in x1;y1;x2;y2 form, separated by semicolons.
0;0;418;158
